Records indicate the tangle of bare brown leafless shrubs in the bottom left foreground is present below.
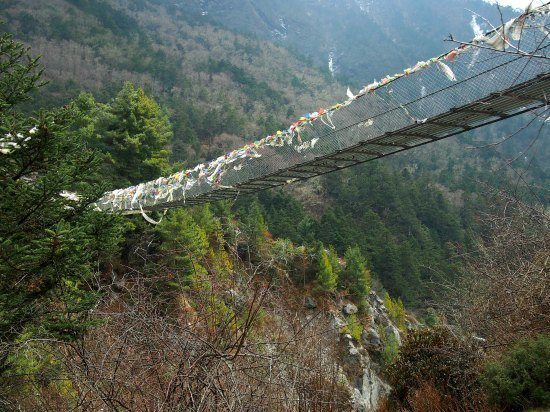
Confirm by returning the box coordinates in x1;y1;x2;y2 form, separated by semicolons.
6;238;350;411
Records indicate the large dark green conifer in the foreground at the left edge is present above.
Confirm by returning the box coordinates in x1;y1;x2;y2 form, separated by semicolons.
0;34;120;373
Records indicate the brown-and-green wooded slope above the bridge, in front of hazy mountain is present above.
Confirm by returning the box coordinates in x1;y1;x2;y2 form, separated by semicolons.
0;0;337;160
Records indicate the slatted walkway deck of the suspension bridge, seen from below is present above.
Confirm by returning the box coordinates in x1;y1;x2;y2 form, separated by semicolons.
178;74;550;208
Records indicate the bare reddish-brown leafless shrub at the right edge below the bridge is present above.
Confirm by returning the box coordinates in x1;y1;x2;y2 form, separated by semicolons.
445;188;550;348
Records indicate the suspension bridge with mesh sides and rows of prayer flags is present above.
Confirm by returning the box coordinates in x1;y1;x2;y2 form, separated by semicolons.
95;3;550;213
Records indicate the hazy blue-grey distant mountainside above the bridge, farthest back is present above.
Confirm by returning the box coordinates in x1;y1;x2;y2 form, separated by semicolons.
177;0;512;85
